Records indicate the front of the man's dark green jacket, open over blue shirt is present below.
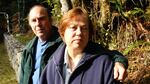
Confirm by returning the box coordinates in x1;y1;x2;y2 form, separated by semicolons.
19;28;62;84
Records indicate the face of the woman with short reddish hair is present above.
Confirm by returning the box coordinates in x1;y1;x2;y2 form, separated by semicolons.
64;15;89;52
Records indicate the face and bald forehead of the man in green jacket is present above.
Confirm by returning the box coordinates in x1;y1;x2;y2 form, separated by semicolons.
29;6;51;39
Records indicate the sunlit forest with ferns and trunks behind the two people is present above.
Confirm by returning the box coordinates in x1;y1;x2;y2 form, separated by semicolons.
0;0;150;84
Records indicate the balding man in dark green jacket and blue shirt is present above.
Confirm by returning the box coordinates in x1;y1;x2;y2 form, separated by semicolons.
19;4;127;84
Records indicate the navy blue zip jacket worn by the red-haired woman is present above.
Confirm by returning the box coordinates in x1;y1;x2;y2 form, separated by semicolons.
40;42;118;84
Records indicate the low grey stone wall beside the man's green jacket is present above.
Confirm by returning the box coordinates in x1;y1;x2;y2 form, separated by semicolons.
4;34;24;80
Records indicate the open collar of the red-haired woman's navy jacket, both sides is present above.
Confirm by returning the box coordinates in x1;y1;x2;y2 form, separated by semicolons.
53;42;106;66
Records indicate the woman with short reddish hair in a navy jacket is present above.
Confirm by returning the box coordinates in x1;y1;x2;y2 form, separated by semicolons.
40;7;119;84
